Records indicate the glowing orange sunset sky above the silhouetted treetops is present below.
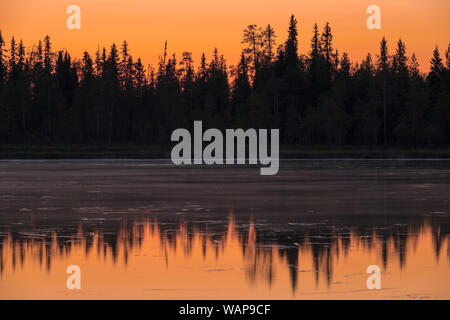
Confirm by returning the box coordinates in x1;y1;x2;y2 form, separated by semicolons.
0;0;450;70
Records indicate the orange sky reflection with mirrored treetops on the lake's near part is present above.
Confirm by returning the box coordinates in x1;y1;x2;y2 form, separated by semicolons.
0;217;450;299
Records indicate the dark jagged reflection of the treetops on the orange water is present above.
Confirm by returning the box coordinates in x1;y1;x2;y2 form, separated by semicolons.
0;216;450;291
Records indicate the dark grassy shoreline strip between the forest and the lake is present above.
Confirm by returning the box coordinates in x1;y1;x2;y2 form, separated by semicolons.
0;145;450;160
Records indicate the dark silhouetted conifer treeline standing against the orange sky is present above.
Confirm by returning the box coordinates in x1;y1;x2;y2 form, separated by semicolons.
0;16;450;147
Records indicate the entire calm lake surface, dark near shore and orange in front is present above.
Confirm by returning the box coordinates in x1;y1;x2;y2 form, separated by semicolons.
0;160;450;299
